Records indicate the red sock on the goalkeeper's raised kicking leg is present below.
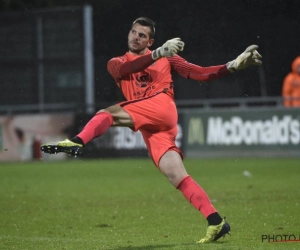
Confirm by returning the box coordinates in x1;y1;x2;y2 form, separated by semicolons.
77;112;113;144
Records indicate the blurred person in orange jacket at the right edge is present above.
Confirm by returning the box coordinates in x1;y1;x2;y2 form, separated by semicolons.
282;56;300;107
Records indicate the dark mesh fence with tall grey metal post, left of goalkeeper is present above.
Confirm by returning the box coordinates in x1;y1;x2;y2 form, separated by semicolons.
0;6;94;112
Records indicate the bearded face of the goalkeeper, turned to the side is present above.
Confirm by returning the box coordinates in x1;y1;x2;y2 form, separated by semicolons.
128;23;154;55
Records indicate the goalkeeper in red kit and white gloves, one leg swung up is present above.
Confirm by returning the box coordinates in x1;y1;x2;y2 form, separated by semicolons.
41;17;261;243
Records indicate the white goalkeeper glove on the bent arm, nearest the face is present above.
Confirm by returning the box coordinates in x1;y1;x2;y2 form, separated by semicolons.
152;38;184;60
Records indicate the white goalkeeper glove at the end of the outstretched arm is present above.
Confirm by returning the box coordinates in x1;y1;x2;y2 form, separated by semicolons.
226;45;262;73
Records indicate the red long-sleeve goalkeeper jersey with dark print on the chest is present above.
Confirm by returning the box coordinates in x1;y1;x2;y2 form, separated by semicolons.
107;50;230;101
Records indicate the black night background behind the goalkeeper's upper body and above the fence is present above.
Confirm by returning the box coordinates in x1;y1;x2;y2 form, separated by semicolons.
0;0;300;101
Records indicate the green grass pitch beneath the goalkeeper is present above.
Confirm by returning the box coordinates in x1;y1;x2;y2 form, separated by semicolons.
0;158;300;250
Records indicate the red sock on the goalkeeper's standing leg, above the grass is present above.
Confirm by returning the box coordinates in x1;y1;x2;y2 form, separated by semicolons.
177;176;217;218
